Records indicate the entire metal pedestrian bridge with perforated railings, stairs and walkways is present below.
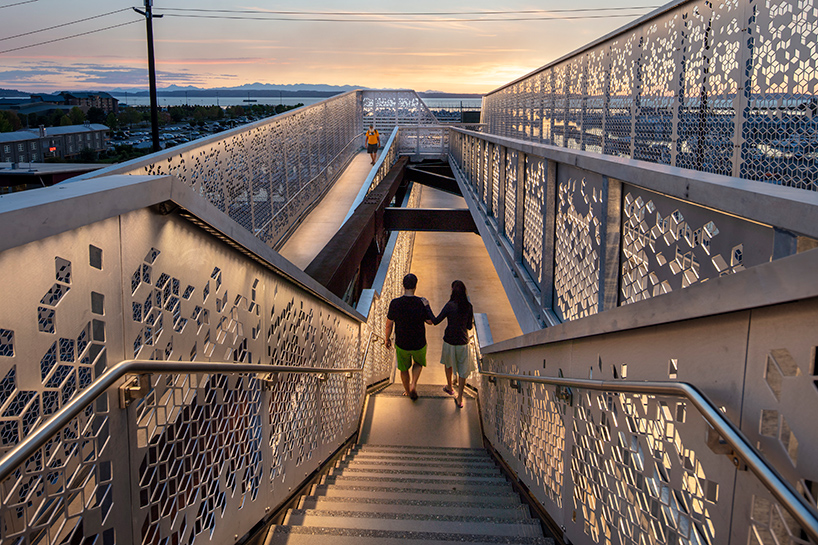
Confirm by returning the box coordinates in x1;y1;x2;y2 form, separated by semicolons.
0;0;818;545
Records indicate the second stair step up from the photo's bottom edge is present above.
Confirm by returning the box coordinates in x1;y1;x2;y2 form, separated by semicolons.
298;496;529;520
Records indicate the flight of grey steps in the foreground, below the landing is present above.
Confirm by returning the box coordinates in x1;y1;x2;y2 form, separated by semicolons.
264;444;553;545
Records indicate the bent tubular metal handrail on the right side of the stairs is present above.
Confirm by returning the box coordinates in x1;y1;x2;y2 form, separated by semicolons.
478;362;818;542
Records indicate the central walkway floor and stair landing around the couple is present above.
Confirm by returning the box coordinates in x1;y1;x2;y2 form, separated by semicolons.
359;187;522;448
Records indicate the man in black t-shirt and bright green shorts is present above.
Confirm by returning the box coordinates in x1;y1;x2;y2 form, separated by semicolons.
384;273;434;400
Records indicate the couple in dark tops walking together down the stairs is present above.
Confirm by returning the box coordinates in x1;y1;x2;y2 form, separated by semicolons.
384;273;474;408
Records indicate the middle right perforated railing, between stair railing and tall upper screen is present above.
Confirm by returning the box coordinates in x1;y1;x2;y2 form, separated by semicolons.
449;129;818;331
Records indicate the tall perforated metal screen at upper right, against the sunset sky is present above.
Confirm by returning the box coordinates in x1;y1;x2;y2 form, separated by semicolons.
483;0;818;191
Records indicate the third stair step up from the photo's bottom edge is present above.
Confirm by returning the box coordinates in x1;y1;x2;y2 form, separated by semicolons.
309;484;520;504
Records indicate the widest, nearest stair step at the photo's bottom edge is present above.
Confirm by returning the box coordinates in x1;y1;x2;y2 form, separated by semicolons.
265;526;554;545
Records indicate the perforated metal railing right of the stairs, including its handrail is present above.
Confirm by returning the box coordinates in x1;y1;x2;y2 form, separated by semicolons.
477;245;818;545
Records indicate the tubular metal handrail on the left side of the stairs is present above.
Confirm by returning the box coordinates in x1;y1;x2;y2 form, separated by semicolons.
0;360;366;482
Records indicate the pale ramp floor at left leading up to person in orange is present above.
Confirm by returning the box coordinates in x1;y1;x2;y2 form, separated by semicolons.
279;151;372;271
